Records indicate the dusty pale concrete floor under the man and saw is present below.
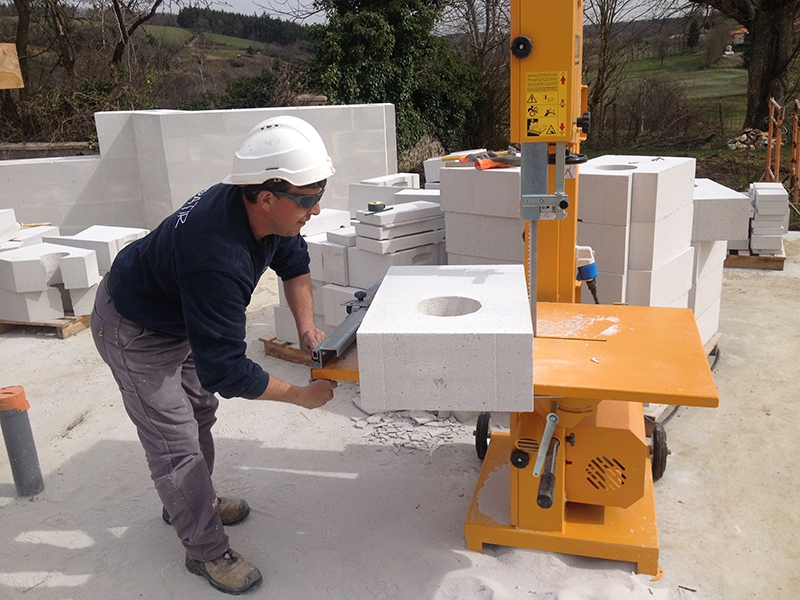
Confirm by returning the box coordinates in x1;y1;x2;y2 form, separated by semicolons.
0;234;800;600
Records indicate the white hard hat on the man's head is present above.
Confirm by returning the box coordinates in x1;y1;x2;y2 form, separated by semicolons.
222;116;336;187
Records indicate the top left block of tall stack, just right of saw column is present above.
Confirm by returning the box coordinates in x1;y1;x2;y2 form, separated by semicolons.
578;169;633;227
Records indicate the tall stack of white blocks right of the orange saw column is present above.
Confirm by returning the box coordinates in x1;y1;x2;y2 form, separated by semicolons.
578;155;695;308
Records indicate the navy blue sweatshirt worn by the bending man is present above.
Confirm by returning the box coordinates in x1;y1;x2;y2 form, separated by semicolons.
108;184;309;398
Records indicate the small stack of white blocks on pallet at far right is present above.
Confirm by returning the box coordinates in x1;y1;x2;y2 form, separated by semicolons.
750;181;789;256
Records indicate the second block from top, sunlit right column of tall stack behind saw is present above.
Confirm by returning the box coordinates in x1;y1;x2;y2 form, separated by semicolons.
628;204;694;271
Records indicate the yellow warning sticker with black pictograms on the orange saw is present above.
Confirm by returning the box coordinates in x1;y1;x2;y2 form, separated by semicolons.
525;71;567;137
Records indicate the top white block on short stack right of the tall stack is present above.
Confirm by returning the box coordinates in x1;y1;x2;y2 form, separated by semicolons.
692;179;750;242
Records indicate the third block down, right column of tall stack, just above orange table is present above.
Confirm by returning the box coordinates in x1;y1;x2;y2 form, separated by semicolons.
626;247;694;306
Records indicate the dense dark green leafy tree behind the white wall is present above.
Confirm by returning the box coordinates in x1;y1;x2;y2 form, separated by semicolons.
309;0;479;152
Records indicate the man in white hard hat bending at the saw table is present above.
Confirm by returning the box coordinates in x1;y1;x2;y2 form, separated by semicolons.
92;117;337;594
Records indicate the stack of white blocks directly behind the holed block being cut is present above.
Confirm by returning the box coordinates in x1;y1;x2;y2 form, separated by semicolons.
439;167;525;265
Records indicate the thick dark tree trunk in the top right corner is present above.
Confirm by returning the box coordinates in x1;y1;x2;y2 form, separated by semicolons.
690;0;800;129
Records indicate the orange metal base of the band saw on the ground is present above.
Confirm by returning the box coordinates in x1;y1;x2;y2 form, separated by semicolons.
464;431;662;579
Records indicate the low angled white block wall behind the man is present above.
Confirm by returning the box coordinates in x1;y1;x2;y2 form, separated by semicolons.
0;104;397;235
